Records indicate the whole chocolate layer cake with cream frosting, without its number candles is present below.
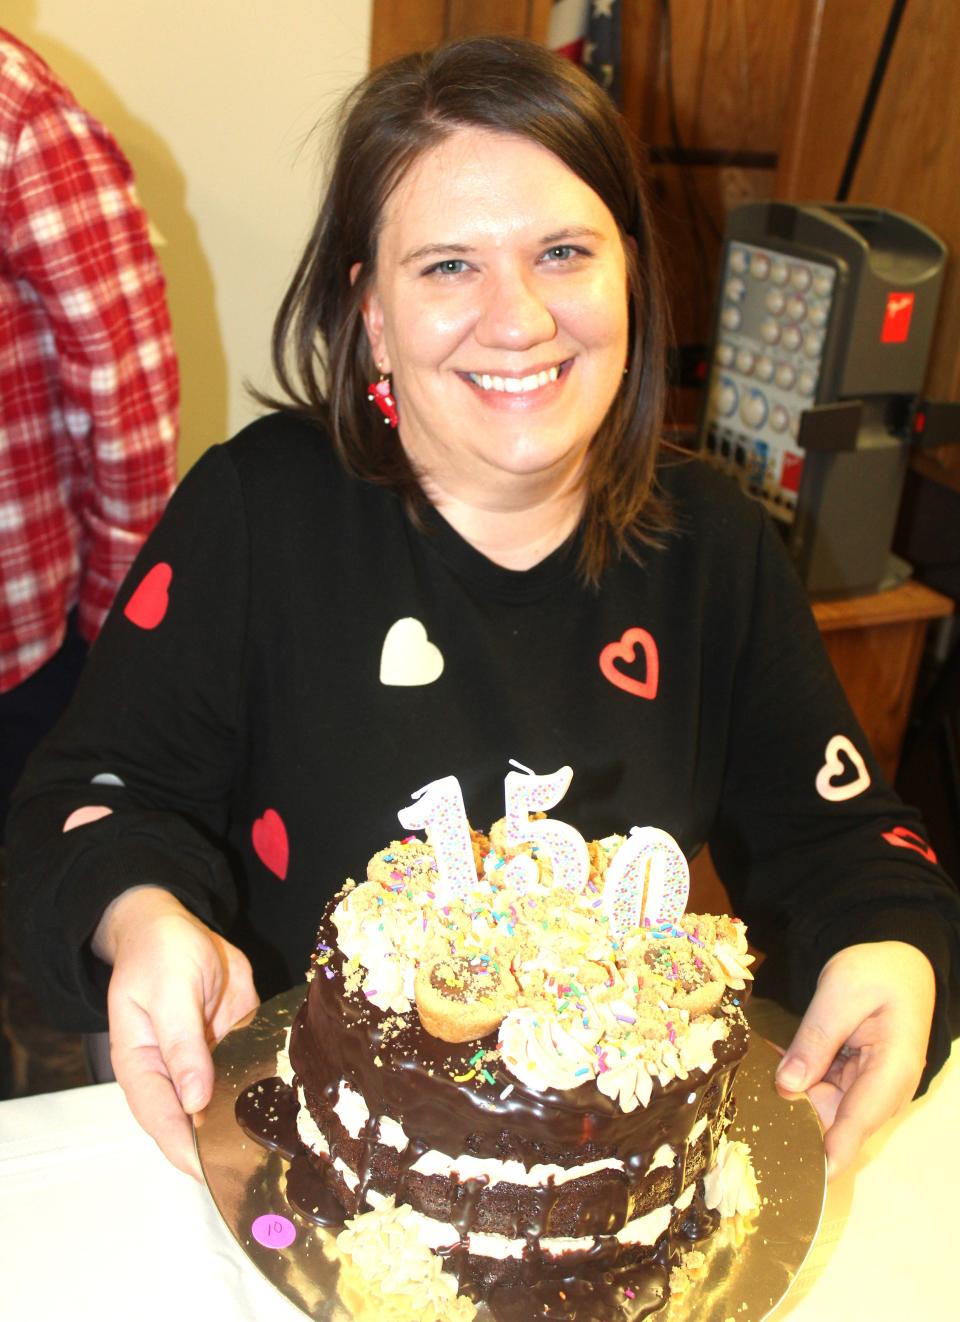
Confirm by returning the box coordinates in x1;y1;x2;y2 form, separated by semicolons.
245;803;752;1318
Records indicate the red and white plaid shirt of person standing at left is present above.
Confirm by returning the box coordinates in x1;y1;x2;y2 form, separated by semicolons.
0;29;179;693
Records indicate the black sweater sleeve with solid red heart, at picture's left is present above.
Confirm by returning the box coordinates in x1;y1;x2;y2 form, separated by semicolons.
7;447;249;1031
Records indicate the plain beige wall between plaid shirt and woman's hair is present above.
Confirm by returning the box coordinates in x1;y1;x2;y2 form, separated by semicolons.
0;0;370;472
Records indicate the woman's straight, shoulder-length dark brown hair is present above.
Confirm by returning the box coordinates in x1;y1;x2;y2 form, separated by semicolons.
263;37;669;583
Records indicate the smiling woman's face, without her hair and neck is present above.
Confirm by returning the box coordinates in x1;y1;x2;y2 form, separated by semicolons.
364;128;628;508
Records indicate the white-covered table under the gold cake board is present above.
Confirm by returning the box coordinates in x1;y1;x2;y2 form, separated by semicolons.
0;1002;960;1322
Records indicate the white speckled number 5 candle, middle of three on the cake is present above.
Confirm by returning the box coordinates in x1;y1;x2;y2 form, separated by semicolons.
504;759;590;891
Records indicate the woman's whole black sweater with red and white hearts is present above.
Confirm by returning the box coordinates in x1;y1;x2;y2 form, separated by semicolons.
8;416;960;1076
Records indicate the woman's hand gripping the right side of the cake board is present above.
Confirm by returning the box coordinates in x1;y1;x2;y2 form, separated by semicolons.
776;941;935;1179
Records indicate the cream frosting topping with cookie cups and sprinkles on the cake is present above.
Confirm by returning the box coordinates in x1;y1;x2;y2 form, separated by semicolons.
326;824;752;1113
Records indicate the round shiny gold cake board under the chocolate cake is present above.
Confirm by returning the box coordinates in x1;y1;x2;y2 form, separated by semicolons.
196;986;826;1322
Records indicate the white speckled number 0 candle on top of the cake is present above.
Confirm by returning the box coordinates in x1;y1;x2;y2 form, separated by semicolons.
603;826;690;939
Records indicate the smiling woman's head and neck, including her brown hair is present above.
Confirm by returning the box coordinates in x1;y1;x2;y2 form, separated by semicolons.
259;38;669;582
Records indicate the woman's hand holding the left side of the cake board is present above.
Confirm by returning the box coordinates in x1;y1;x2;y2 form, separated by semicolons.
93;886;259;1179
